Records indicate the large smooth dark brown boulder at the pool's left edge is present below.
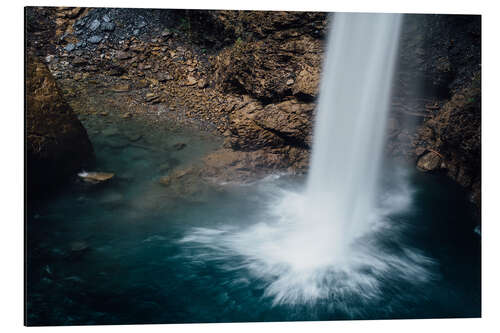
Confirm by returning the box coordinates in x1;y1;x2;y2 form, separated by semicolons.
26;55;94;196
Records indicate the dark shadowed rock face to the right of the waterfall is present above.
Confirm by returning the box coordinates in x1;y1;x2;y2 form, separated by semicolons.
387;14;481;205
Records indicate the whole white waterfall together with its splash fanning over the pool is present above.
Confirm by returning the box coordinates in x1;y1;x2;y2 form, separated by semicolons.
181;13;433;307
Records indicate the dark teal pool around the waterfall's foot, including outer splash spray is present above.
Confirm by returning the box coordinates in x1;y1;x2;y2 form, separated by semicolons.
26;116;481;325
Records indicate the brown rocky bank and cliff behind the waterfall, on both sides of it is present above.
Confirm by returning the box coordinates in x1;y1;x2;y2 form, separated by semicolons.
26;7;481;205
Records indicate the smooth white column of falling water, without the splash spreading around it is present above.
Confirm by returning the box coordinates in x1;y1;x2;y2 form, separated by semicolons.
307;13;401;252
